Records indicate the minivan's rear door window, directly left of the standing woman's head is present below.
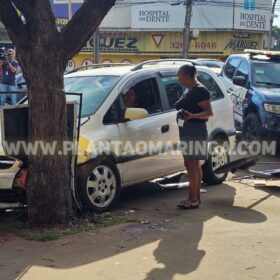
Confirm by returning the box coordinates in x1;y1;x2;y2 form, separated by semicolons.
161;76;184;109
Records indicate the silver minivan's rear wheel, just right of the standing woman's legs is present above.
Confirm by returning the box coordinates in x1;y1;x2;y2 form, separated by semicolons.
202;138;230;185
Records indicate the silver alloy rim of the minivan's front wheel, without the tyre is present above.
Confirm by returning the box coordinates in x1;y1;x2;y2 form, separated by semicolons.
87;165;117;207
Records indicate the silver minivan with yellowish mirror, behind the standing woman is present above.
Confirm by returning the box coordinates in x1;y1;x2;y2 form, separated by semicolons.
0;62;235;212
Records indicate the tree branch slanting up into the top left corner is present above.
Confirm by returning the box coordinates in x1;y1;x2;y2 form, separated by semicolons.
0;0;28;47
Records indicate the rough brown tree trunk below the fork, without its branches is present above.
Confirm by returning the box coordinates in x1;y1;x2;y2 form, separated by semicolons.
23;48;72;224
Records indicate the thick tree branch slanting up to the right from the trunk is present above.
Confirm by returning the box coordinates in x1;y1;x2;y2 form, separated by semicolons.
61;0;116;62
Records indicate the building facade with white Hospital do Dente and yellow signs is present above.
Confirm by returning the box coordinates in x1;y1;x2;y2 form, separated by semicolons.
0;0;272;69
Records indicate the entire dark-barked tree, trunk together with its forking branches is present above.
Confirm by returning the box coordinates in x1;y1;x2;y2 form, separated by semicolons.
0;0;115;225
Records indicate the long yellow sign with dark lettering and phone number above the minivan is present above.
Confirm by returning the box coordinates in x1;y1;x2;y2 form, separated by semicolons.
71;31;266;67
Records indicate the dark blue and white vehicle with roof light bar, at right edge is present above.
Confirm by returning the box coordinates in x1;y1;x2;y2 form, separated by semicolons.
220;50;280;140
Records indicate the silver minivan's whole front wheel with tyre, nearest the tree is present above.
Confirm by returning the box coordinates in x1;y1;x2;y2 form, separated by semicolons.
77;160;121;213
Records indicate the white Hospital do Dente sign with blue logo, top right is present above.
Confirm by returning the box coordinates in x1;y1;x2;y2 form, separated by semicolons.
234;0;271;31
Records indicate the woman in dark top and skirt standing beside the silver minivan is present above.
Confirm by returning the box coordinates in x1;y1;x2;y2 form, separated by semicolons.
175;64;213;209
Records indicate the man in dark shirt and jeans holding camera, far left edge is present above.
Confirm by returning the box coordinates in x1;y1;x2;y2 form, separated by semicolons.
0;49;18;106
